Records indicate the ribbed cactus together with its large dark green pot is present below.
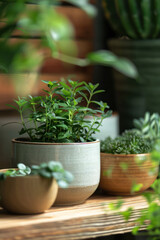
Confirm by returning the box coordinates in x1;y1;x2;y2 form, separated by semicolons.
103;0;160;132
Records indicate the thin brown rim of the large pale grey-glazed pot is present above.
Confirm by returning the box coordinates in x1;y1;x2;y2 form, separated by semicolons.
12;138;100;146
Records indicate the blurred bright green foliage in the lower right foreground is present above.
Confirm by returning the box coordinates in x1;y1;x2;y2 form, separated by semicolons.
104;179;160;240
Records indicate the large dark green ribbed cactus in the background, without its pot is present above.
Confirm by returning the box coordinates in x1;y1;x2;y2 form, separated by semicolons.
103;0;160;39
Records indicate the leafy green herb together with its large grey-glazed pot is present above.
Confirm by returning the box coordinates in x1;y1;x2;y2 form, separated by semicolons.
9;79;111;205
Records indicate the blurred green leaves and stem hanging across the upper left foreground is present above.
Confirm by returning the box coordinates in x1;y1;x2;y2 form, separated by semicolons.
0;0;137;80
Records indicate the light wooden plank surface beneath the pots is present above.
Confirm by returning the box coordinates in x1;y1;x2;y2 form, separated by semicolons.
0;194;147;240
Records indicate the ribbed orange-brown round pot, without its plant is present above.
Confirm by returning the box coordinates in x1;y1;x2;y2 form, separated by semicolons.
99;153;158;195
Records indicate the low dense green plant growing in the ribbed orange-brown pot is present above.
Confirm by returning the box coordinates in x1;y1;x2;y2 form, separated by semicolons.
101;129;153;154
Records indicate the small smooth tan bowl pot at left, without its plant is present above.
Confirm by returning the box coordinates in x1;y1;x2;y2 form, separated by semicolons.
0;170;58;214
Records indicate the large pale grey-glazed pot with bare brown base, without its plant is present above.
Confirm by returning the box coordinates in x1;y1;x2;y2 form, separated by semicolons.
12;139;100;205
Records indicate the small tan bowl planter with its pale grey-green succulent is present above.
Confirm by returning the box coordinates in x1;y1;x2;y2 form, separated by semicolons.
0;161;73;214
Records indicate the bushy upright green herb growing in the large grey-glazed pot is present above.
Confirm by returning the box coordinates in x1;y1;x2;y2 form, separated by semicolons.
12;79;111;143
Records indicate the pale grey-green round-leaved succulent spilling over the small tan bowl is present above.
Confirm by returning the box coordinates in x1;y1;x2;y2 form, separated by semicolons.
0;161;73;188
